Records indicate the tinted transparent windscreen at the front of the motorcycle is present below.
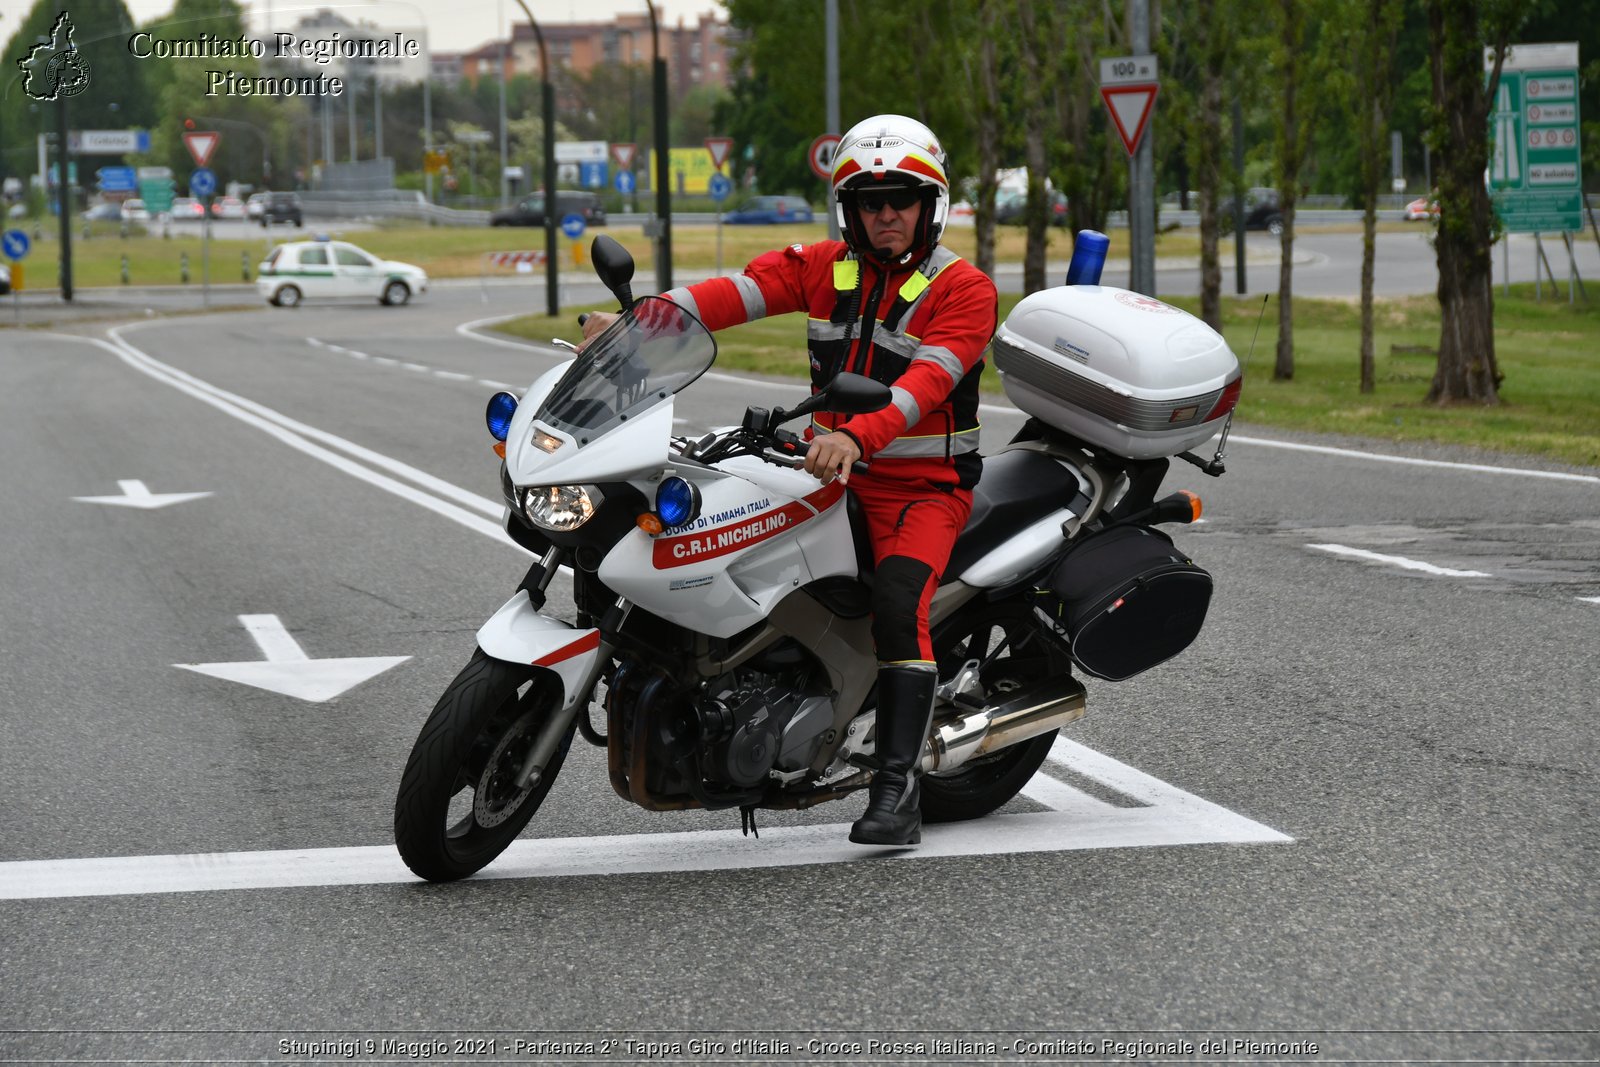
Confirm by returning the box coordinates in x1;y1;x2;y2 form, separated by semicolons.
534;296;717;438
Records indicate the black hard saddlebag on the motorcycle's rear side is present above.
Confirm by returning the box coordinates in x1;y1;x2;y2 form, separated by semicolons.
1040;525;1211;681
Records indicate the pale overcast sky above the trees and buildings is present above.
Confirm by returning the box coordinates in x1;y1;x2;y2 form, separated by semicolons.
0;0;722;51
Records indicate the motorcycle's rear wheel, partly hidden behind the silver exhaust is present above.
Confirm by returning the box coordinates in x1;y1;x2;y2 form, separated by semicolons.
922;600;1072;822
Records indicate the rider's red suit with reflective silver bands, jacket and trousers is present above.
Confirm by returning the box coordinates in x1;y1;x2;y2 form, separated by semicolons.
666;242;997;667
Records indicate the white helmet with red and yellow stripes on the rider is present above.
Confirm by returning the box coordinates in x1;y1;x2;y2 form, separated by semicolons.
832;115;950;256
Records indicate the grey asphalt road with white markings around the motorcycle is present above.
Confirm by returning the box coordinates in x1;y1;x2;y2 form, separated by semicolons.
0;290;1600;1062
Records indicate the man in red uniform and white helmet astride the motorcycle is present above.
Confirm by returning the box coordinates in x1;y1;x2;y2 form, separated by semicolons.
584;115;997;845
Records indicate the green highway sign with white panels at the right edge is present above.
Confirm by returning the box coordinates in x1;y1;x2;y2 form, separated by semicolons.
1485;43;1584;234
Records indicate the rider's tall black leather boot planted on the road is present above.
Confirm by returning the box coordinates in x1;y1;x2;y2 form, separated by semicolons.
850;667;939;845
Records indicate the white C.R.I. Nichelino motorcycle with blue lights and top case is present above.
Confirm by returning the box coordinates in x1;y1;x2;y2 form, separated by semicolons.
395;237;1240;880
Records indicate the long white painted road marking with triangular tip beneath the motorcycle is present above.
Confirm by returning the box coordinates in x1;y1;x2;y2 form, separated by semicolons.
0;739;1294;901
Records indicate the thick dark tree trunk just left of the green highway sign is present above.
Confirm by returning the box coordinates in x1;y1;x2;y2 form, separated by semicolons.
1426;0;1526;405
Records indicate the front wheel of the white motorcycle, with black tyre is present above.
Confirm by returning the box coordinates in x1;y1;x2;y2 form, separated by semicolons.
395;649;576;881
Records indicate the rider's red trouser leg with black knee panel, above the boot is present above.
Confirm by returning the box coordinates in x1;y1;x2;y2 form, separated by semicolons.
850;475;973;669
